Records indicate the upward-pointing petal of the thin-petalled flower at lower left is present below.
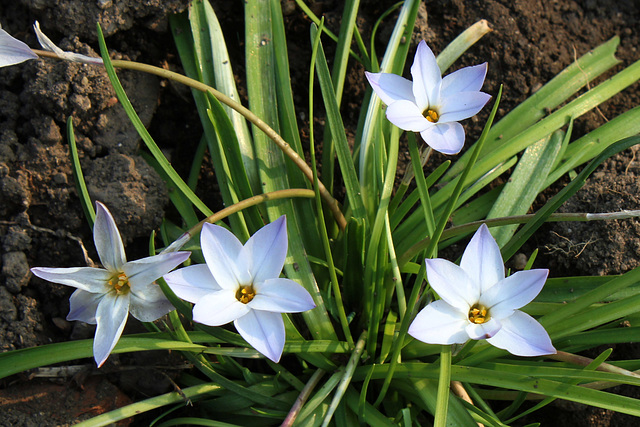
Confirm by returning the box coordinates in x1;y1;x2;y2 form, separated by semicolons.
93;202;127;273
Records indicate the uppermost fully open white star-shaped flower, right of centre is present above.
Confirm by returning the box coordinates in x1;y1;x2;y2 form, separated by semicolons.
365;40;491;154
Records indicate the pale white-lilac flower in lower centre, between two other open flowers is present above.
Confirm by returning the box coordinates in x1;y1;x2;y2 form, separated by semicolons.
164;216;315;362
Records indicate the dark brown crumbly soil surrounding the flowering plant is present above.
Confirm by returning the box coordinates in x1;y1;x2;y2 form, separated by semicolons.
0;0;640;426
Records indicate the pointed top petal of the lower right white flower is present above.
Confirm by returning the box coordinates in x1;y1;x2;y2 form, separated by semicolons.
460;224;504;294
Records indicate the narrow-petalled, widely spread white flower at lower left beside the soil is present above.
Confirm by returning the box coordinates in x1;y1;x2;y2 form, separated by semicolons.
31;202;191;367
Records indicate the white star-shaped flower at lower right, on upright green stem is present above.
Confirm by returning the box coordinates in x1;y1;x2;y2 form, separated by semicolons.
409;224;556;356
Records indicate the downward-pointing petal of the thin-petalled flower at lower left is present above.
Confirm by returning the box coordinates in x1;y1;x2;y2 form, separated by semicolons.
93;293;129;368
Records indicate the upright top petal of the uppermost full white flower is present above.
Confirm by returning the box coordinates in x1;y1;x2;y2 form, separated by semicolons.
411;40;442;112
